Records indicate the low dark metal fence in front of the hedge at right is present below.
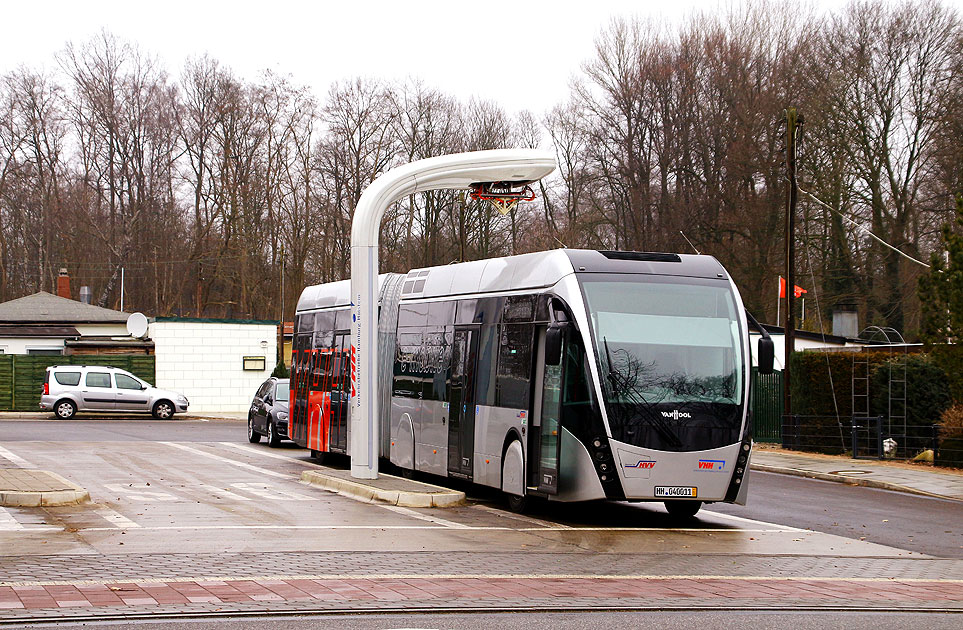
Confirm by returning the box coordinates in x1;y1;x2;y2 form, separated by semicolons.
782;415;963;467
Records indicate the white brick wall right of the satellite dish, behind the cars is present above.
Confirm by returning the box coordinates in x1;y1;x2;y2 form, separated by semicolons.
148;321;277;414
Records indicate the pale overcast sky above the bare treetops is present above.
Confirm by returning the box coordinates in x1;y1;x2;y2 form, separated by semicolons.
0;0;963;115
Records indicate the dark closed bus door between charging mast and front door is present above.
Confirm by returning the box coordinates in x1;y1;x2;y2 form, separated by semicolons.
448;329;478;477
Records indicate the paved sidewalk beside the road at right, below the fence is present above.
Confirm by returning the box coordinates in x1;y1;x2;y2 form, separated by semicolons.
751;444;963;501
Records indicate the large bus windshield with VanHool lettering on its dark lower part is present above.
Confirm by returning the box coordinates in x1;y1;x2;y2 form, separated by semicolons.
580;274;745;451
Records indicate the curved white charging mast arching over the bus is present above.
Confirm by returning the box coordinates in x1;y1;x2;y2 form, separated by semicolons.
348;149;555;479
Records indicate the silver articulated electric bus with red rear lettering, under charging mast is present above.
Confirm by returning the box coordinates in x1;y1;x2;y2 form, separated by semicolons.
290;249;772;515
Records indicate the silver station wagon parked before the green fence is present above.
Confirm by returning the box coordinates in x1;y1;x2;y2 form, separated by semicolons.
40;365;188;420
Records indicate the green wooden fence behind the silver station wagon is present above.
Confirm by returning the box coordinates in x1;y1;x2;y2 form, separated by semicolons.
0;354;154;411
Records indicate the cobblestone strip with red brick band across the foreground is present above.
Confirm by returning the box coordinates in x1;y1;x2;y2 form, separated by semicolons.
0;552;963;623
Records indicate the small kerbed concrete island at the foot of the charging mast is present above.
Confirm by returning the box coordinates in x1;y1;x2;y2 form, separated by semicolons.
301;468;465;508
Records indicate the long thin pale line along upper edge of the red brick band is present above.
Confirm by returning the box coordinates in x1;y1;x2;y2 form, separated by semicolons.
0;573;963;587
